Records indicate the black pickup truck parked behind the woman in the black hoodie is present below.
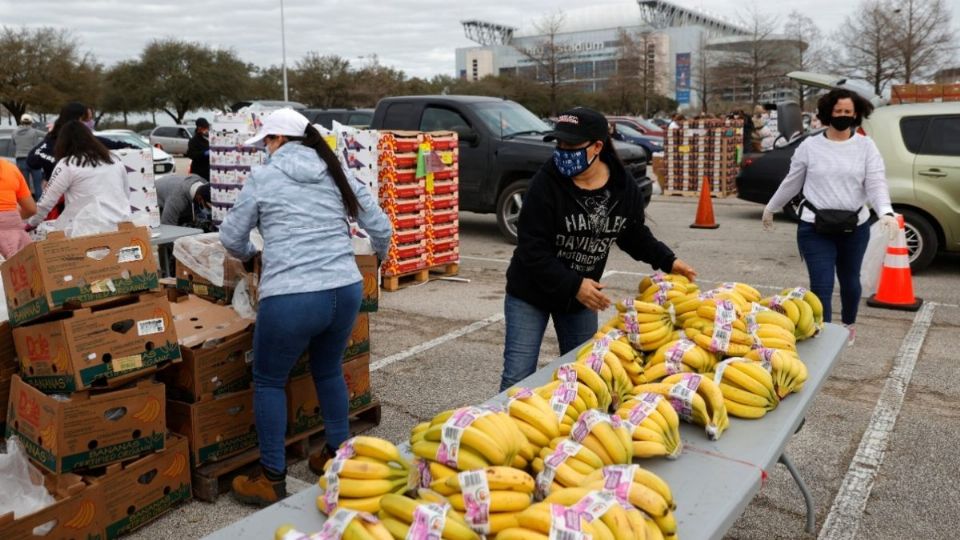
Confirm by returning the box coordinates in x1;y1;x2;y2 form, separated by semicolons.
370;95;653;243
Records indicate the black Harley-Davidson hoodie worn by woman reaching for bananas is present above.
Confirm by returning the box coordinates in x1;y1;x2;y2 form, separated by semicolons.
507;152;676;313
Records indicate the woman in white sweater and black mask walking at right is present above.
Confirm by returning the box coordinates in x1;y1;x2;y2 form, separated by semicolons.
763;89;899;344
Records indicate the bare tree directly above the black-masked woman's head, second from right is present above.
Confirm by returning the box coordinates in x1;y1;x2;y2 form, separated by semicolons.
836;0;899;95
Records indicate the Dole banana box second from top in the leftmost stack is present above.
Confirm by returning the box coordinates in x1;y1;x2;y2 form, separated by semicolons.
13;294;180;394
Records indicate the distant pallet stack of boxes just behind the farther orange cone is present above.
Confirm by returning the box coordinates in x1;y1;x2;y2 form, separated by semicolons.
663;119;743;198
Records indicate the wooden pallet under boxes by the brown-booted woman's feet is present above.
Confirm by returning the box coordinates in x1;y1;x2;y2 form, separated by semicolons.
192;399;381;502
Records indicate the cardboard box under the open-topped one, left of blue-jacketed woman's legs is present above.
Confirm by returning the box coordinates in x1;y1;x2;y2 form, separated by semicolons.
167;390;257;466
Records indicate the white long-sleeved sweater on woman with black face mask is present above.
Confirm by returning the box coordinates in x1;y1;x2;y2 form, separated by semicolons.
766;133;893;224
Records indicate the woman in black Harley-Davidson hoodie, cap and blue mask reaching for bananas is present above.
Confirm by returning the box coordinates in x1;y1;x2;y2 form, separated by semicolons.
500;107;696;391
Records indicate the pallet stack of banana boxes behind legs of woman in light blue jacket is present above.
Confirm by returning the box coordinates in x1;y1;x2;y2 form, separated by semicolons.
161;234;380;501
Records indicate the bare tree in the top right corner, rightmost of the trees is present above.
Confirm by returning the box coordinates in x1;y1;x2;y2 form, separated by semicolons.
886;0;955;84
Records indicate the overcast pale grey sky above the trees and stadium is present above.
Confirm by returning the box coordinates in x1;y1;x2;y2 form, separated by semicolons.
0;0;916;76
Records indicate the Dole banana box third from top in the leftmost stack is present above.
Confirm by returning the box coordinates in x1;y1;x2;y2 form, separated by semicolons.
7;376;166;474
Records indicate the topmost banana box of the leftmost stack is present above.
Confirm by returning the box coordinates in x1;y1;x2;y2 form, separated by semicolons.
2;223;159;326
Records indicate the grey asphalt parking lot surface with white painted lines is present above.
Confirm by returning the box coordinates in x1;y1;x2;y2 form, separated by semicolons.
137;193;960;539
